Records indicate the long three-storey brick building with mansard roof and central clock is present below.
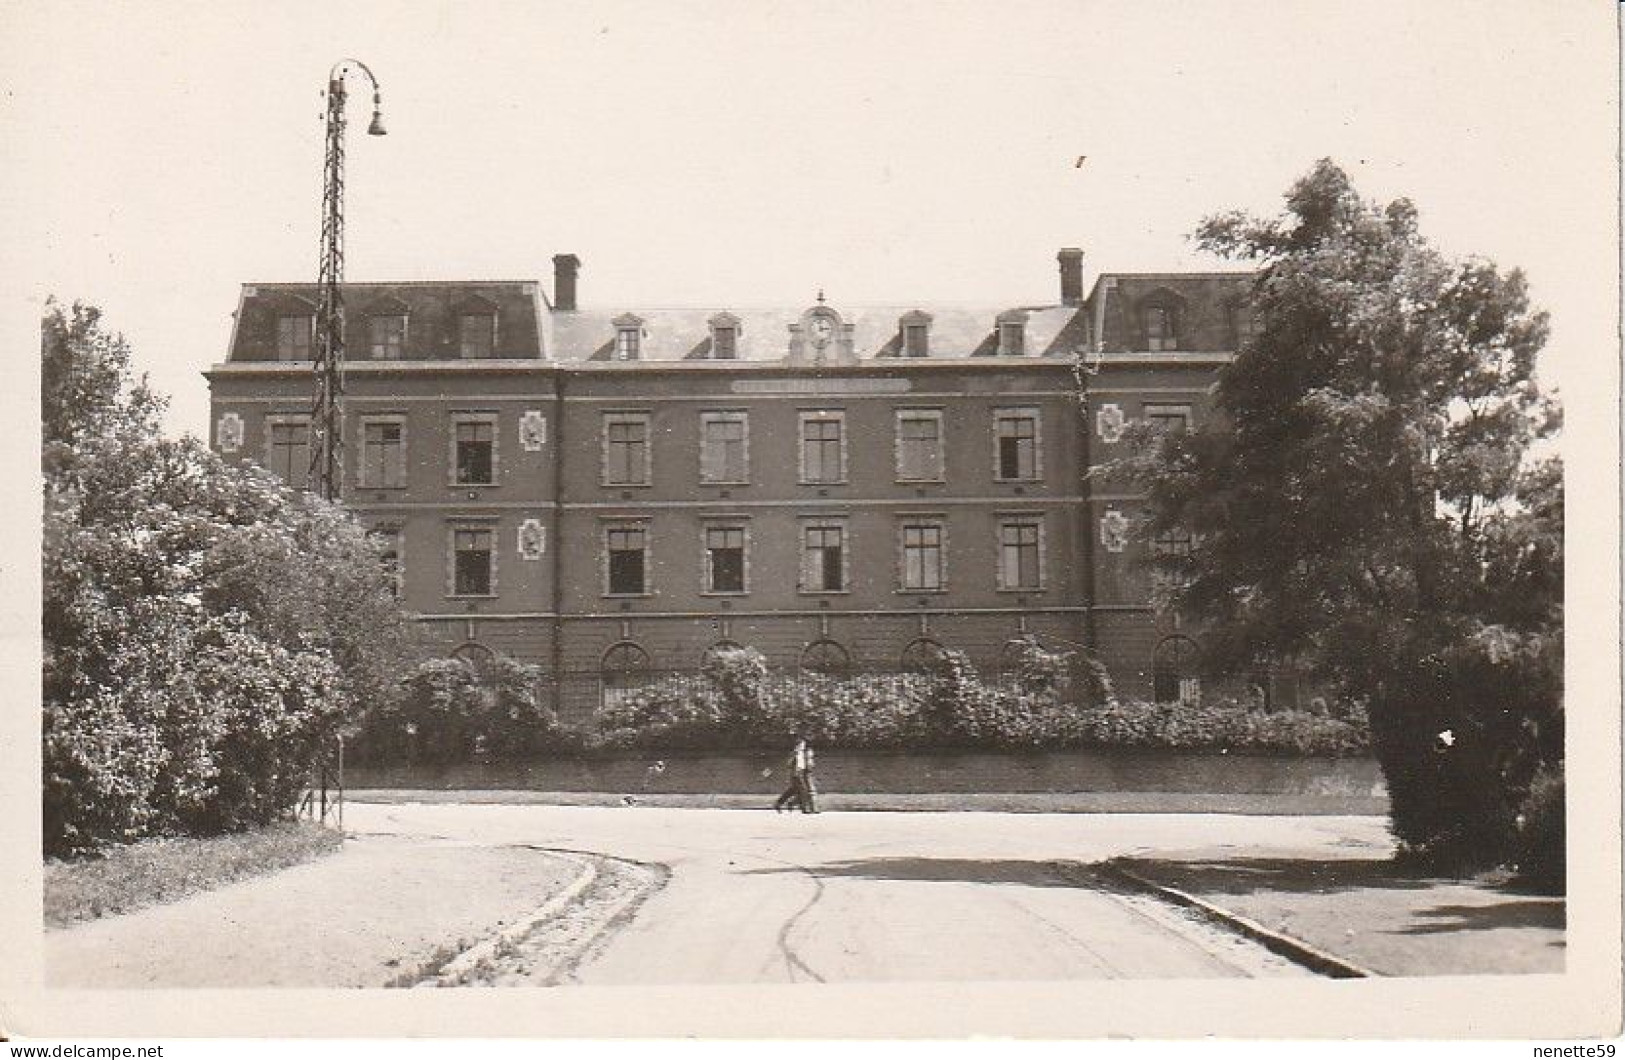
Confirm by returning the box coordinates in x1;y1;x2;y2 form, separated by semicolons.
208;249;1248;715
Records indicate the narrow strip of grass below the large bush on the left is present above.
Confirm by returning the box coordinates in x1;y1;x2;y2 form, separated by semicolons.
46;821;343;928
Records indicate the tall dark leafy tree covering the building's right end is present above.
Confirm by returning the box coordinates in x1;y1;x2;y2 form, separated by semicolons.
1115;161;1563;863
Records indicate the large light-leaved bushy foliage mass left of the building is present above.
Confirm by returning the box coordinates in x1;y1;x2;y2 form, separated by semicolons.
42;304;405;852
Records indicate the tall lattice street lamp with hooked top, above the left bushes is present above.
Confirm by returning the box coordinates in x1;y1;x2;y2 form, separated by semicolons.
310;59;385;501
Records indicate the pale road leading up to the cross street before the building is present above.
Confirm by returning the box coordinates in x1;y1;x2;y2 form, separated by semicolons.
346;803;1388;985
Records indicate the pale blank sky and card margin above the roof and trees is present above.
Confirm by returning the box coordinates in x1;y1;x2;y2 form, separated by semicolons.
0;0;1619;434
